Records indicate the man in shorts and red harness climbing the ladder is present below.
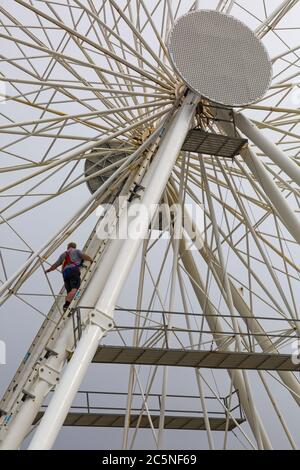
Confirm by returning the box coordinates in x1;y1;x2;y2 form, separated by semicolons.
46;242;93;311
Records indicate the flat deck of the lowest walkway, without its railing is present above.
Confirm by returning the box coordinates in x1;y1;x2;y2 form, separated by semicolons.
34;411;245;431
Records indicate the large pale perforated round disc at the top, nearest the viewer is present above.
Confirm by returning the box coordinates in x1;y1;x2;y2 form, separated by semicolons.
168;10;272;106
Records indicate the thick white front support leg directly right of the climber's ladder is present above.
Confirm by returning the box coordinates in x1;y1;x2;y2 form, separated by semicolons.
29;92;199;450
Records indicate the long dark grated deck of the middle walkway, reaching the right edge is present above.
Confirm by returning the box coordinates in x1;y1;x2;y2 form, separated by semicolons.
93;346;300;371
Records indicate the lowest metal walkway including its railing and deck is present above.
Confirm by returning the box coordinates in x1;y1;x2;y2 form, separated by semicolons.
34;390;245;431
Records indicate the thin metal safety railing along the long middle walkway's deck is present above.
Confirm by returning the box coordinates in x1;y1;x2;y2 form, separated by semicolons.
72;306;300;354
